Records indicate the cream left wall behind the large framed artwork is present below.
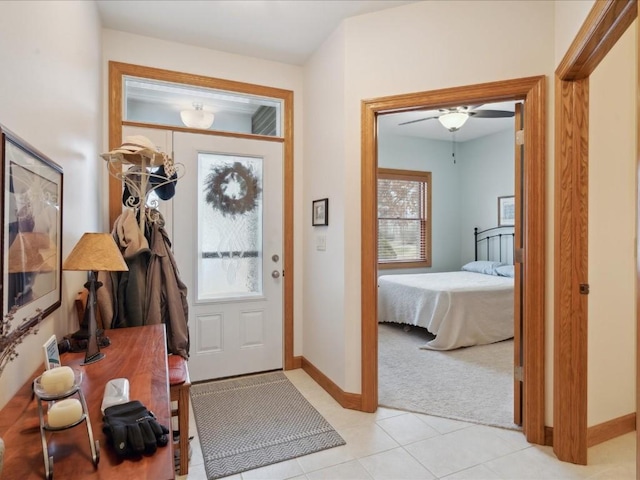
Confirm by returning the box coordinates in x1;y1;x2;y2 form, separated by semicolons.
0;1;103;407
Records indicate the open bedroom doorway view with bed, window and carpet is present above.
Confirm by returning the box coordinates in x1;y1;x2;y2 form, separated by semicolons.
377;101;522;430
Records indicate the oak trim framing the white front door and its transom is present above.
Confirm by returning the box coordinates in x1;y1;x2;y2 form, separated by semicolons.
109;61;296;370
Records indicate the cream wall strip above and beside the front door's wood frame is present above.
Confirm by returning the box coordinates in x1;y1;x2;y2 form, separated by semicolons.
102;29;310;355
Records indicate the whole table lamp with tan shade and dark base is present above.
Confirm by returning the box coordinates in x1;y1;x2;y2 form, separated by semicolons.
62;233;129;365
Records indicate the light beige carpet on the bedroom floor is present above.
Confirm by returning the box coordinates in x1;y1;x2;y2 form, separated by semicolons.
378;323;519;429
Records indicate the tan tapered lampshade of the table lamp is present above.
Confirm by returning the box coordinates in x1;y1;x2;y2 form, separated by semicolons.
62;233;129;272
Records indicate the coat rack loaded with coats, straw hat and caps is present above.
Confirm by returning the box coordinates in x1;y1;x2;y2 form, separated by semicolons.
98;135;189;359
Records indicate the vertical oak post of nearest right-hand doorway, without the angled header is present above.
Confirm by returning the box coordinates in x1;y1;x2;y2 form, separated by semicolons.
553;78;589;465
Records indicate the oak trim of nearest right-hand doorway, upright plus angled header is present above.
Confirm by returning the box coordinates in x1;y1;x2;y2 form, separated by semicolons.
553;0;640;464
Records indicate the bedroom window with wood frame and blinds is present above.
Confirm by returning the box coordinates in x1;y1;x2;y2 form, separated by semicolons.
378;168;431;268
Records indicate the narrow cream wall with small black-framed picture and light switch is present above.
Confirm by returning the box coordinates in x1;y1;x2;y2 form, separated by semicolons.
302;28;348;385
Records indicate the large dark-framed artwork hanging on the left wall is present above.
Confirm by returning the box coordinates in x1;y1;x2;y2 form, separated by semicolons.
0;125;63;319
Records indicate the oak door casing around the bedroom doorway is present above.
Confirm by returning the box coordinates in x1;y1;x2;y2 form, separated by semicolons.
361;76;546;444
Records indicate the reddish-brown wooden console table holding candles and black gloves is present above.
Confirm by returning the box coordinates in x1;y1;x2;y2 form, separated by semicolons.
0;325;175;480
